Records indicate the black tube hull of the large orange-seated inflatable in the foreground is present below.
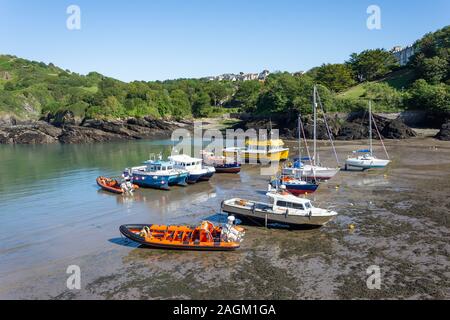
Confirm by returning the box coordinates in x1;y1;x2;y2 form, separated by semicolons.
119;224;240;251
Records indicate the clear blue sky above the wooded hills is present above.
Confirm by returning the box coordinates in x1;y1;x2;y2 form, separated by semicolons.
0;0;450;81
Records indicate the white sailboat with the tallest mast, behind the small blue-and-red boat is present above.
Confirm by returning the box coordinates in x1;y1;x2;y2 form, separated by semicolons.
282;86;340;180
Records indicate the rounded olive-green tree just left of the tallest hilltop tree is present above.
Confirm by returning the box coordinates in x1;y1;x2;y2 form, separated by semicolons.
314;64;356;92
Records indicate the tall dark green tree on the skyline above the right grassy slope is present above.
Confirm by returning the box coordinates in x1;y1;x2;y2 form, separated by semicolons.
347;49;398;82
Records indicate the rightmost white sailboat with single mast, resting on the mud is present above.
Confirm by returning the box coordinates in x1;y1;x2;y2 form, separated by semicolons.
345;101;391;170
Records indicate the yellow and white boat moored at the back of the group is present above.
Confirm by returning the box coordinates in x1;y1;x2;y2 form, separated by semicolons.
223;139;289;162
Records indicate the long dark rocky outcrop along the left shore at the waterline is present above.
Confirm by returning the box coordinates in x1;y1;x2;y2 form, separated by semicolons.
0;117;190;144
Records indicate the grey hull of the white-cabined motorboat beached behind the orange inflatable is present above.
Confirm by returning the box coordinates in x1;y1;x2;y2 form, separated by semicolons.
222;202;334;227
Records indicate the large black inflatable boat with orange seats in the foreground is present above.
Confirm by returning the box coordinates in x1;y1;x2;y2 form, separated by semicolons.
120;217;245;251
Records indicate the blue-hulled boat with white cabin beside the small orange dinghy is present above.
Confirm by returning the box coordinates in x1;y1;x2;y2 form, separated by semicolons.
124;160;189;190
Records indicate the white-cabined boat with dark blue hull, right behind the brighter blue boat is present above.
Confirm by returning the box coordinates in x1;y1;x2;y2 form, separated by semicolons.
169;154;216;184
